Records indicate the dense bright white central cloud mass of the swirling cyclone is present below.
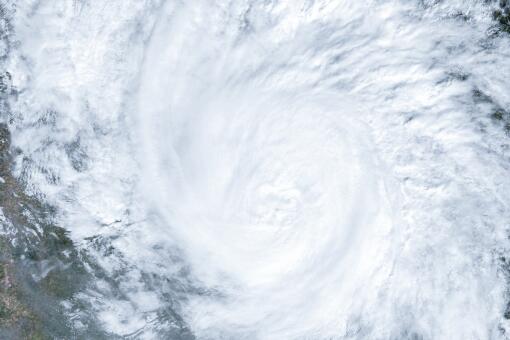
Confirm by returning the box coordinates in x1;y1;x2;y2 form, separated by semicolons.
138;4;398;339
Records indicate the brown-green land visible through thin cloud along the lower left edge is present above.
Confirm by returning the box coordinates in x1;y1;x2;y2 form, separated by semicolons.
0;124;96;339
